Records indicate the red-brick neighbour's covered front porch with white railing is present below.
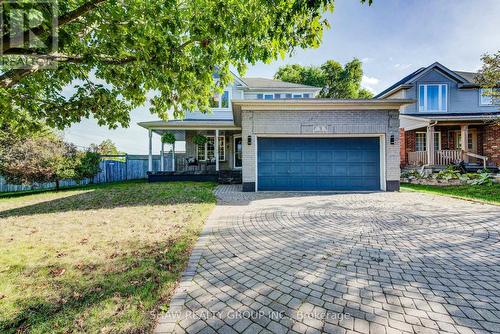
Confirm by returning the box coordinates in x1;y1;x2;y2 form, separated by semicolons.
400;117;496;169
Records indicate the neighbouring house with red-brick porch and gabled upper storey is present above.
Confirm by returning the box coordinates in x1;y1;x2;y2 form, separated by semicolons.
375;63;500;167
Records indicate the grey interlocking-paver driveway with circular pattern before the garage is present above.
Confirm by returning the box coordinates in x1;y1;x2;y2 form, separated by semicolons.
156;186;500;333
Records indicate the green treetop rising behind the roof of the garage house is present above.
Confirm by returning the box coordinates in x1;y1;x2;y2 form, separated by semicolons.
274;58;373;99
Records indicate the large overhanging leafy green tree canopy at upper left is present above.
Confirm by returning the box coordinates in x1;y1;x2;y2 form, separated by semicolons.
0;0;371;134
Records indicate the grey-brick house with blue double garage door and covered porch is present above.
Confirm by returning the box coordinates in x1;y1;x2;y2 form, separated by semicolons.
139;76;414;191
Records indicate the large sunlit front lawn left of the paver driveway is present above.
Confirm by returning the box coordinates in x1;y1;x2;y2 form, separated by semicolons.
0;182;215;333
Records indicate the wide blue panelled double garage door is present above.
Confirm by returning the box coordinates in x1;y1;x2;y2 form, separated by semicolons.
257;138;380;190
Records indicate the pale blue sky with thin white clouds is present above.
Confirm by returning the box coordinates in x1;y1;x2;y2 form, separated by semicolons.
64;0;500;154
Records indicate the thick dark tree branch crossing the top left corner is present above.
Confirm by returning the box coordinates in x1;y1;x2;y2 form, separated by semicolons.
2;0;107;54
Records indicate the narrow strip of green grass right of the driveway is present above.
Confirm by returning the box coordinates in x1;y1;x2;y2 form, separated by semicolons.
401;183;500;204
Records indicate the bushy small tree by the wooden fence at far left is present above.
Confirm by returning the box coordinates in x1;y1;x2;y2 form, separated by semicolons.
0;127;99;189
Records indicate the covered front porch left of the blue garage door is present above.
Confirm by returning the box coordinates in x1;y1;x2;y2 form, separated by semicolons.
140;121;242;184
